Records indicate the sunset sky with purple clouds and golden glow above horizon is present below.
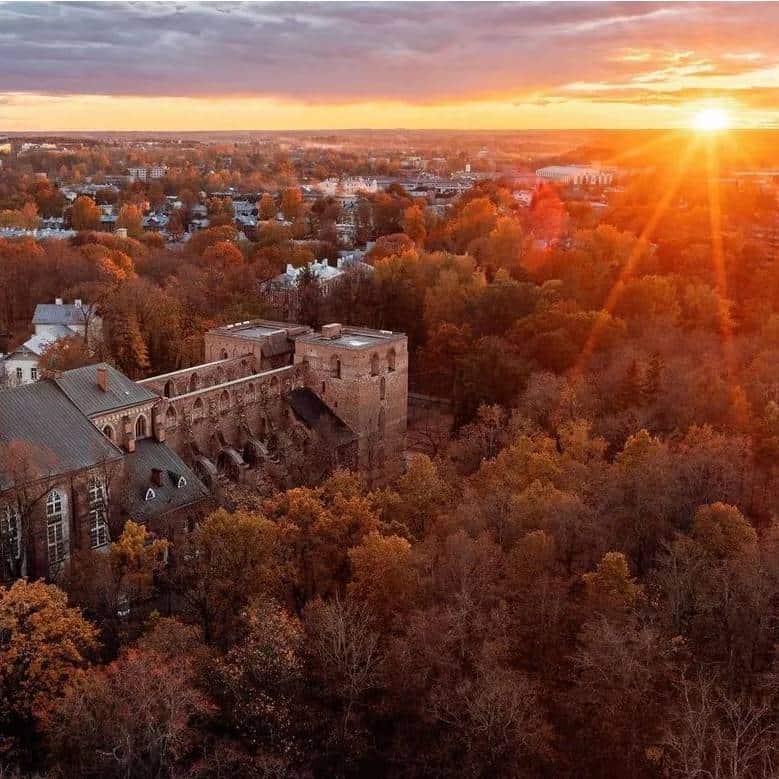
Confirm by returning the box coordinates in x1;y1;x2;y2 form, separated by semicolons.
0;0;779;133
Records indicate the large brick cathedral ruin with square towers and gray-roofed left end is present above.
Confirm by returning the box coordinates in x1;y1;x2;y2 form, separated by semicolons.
0;320;408;578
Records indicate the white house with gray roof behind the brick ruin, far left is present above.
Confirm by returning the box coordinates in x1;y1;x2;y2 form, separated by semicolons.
0;298;102;386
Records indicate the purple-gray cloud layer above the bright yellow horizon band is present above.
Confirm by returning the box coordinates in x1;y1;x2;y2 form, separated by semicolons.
0;2;779;103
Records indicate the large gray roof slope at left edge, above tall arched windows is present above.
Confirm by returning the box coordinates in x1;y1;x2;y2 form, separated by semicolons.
0;379;122;489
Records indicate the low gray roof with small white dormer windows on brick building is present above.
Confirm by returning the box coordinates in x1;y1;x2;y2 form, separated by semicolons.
125;438;209;522
